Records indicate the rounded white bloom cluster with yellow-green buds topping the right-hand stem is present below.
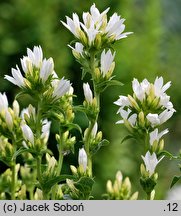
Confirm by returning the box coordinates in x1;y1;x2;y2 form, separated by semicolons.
114;77;175;131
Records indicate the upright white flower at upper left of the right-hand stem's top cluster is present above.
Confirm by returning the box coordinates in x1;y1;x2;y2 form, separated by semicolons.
132;78;150;101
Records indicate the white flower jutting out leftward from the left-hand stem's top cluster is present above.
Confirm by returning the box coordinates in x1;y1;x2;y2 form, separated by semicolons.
4;66;25;87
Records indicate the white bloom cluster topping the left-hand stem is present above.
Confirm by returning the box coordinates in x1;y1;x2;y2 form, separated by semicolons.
5;46;71;99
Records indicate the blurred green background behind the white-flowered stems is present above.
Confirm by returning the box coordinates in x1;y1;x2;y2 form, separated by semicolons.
0;0;181;199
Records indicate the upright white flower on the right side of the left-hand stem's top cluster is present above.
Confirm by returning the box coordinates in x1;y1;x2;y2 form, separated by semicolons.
40;58;54;83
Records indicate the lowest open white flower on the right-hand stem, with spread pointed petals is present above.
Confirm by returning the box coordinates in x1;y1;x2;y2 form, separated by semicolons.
141;151;164;177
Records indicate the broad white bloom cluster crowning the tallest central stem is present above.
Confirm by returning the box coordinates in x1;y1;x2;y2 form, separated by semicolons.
61;4;131;48
